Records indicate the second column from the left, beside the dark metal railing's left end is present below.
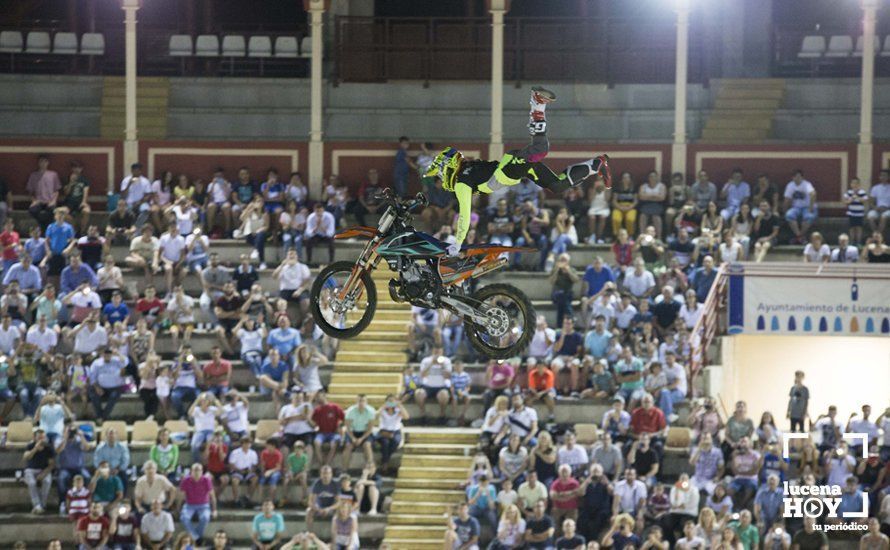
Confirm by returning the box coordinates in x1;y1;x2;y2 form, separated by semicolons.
303;0;329;196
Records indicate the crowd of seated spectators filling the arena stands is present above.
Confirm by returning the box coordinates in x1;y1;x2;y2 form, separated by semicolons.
0;151;890;550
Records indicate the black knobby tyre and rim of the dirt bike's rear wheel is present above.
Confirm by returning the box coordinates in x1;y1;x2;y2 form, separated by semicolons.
464;284;535;359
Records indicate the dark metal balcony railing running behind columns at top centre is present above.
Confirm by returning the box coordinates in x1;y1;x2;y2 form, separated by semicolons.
332;16;708;84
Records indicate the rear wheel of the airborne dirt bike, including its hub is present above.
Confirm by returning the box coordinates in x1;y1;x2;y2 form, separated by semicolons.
464;284;535;359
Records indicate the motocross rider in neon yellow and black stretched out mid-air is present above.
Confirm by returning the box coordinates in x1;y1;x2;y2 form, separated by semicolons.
426;86;612;256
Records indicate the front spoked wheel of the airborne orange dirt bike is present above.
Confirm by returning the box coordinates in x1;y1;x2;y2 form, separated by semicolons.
310;262;377;338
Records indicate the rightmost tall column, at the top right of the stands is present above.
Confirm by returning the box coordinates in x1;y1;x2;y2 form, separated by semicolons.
843;0;878;186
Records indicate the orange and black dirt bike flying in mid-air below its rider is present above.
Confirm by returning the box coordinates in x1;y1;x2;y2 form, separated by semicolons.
310;189;537;359
